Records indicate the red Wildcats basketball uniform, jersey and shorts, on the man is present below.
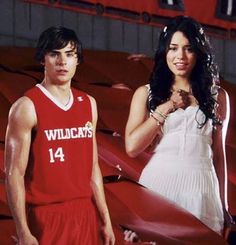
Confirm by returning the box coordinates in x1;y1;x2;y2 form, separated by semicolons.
25;85;101;244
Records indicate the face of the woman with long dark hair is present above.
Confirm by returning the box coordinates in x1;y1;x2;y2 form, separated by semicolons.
166;31;197;78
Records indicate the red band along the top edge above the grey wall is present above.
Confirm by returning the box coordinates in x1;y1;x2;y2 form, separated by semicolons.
25;0;236;31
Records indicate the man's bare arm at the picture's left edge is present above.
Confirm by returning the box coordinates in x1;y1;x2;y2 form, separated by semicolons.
5;97;38;244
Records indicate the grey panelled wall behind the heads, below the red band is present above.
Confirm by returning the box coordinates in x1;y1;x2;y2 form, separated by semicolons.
0;0;236;83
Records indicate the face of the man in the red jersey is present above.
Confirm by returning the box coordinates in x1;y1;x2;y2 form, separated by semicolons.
44;43;78;84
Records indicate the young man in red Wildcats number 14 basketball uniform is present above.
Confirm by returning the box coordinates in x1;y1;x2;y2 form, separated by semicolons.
5;27;115;245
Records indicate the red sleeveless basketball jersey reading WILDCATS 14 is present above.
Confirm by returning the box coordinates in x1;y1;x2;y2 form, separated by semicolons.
25;85;93;205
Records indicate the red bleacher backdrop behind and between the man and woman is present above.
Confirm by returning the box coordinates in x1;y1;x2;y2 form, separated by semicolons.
0;47;236;244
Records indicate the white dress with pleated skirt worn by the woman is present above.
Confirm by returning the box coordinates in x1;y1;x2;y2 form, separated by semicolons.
139;106;224;233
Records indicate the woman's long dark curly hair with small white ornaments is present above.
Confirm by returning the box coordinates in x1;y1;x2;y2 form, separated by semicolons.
148;16;220;127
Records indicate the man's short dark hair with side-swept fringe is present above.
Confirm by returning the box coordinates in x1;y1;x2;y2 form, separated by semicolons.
35;26;83;62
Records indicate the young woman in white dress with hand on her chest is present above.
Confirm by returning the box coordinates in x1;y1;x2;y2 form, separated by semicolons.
125;16;229;233
